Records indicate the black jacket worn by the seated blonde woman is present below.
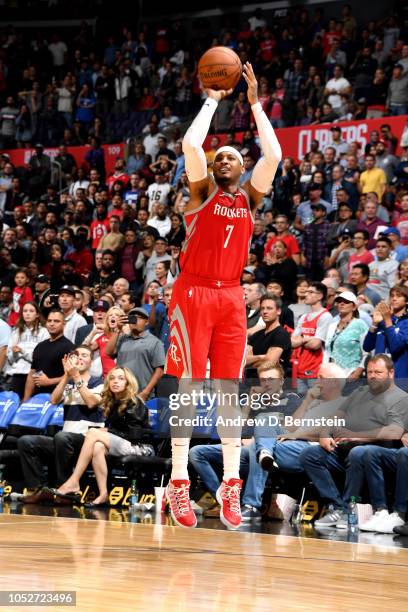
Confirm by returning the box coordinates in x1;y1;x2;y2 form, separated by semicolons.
105;401;149;442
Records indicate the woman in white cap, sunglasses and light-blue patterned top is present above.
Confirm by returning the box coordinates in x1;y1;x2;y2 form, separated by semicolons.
323;291;368;380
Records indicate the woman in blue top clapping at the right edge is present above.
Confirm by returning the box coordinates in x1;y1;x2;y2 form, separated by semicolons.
364;285;408;378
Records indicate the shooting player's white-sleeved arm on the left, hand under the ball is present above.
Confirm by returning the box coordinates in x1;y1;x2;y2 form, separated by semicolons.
183;89;232;210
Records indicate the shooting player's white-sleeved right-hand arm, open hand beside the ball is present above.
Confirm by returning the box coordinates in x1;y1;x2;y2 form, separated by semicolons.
243;62;282;210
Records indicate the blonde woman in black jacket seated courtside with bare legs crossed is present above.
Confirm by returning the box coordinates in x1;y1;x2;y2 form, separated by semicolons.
56;367;150;507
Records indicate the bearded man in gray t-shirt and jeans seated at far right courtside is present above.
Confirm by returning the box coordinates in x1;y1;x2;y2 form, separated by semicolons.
299;353;408;528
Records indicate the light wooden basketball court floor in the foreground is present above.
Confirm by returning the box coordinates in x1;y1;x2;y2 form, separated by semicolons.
0;508;408;612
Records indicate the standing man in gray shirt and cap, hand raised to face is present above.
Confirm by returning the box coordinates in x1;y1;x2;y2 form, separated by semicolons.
105;308;165;402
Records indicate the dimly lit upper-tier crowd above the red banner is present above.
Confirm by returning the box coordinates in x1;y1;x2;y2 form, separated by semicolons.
0;5;408;151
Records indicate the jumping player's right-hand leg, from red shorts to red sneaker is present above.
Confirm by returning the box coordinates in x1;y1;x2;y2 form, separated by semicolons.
210;287;246;529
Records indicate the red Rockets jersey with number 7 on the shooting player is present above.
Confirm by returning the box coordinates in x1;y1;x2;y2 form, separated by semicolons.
180;186;254;282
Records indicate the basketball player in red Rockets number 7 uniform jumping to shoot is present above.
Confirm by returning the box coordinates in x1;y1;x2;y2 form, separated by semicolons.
166;62;282;529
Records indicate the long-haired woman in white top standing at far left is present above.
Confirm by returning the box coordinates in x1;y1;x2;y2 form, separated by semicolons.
6;302;50;398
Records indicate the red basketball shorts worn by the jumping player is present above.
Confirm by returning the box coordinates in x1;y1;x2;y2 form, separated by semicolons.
166;273;247;379
